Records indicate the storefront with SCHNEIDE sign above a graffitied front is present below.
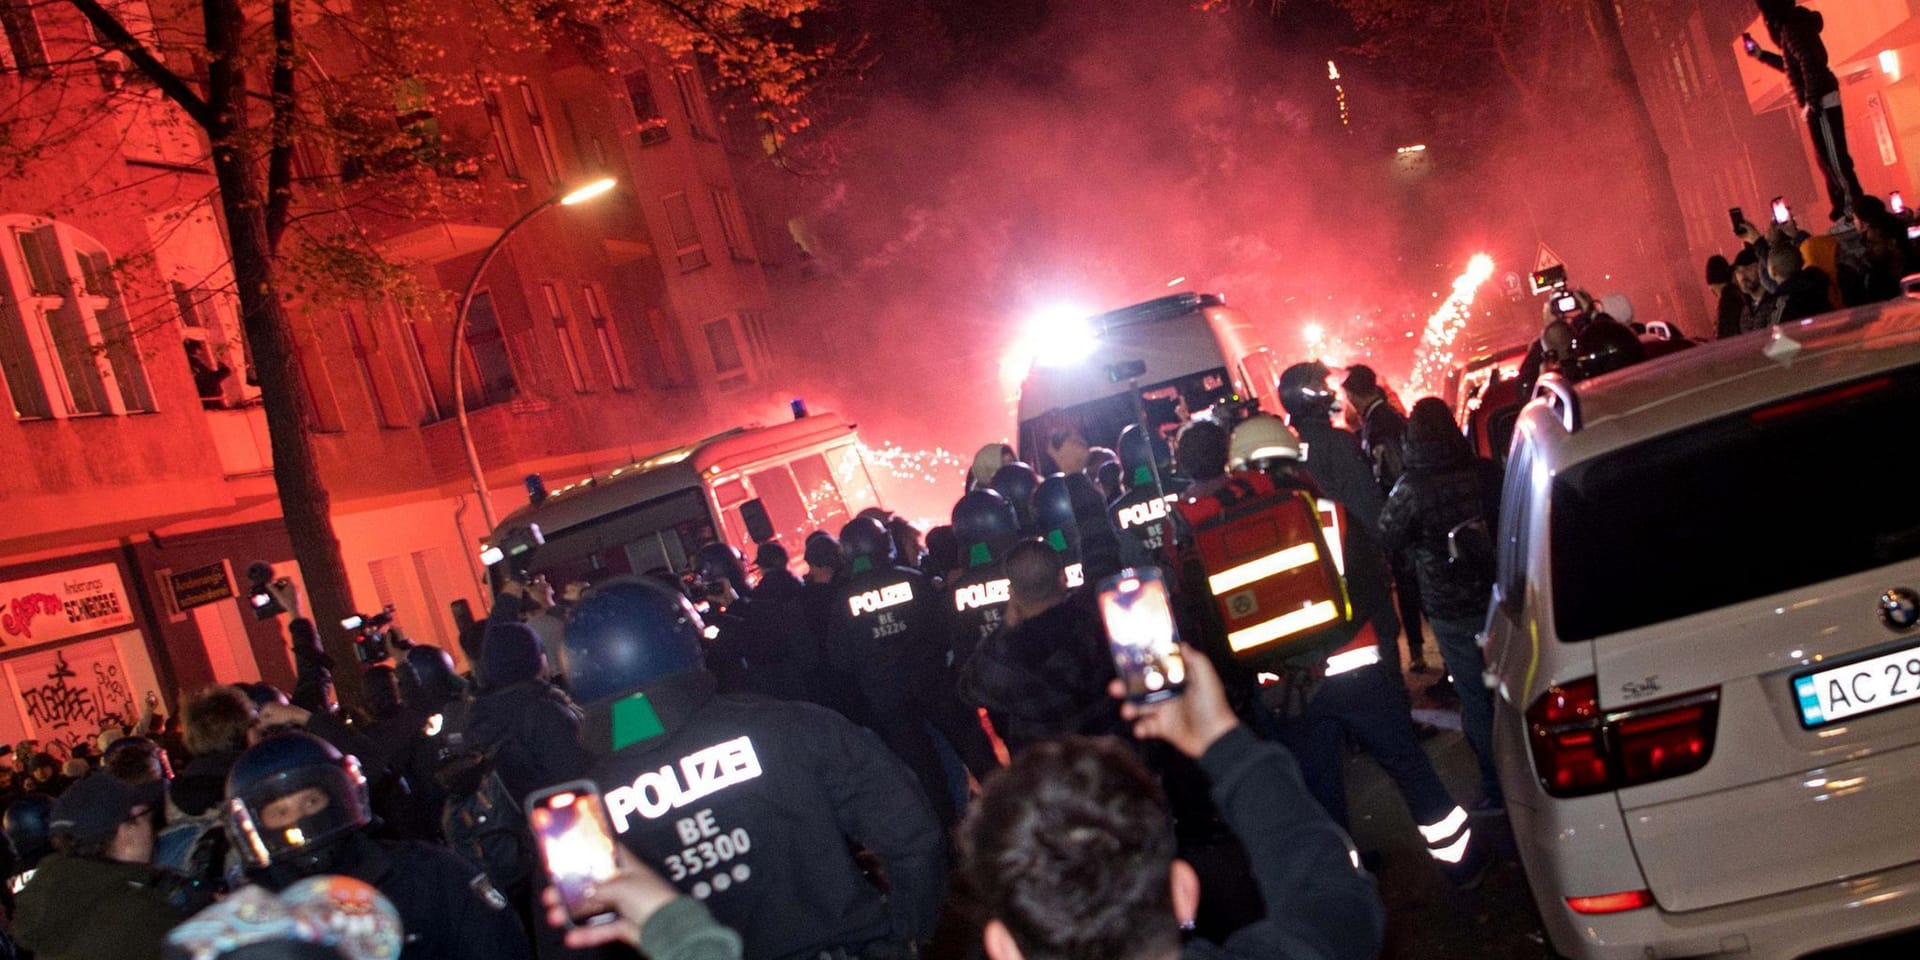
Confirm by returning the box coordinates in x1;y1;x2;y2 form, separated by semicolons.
0;559;161;743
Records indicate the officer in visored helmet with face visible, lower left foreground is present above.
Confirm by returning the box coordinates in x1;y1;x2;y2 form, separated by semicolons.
223;732;532;960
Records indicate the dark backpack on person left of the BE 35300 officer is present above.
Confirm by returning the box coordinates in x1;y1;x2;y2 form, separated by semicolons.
434;701;536;891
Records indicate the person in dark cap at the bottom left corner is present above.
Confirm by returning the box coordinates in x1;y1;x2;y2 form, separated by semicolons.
13;774;202;960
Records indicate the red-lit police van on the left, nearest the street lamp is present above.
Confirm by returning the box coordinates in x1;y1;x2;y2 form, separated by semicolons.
480;413;879;588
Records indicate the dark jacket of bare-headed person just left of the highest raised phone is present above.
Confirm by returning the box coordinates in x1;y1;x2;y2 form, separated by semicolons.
960;591;1125;753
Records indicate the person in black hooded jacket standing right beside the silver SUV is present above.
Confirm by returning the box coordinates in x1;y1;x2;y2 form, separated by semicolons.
1380;397;1501;803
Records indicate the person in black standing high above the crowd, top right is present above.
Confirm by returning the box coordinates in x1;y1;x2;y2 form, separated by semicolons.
1743;0;1864;223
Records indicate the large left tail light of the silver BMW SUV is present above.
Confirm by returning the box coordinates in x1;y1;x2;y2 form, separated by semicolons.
1526;678;1720;797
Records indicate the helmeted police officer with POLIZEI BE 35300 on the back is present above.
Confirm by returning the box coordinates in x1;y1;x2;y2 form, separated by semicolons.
566;580;945;960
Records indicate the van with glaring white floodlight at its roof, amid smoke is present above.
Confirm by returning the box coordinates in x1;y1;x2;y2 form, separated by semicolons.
1018;294;1281;472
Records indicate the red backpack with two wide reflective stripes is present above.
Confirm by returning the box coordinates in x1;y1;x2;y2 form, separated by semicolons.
1179;472;1354;662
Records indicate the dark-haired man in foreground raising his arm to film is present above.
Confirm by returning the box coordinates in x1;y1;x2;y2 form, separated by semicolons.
958;647;1384;960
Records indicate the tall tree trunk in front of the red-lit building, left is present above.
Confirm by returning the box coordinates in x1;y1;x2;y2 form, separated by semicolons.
205;0;367;705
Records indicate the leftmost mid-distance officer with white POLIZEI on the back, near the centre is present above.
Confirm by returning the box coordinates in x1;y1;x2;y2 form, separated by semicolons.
828;516;998;829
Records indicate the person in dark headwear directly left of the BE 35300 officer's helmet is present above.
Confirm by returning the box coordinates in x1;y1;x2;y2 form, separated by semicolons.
465;622;589;797
